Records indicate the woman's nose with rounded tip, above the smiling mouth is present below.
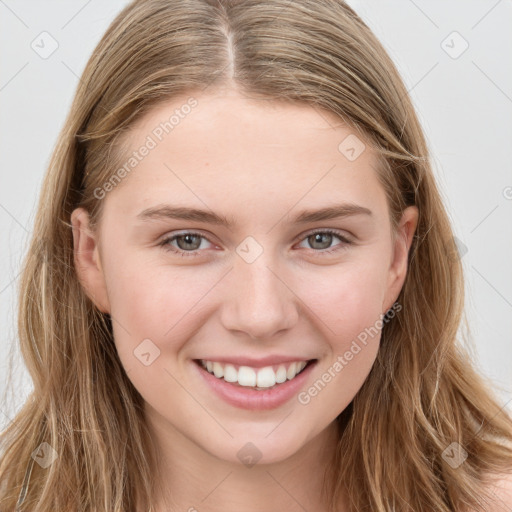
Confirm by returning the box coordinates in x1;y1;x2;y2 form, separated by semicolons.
221;253;299;340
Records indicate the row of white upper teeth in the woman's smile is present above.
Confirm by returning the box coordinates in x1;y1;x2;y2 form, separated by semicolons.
201;359;307;389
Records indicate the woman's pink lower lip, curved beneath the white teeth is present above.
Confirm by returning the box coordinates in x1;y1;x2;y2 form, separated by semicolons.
193;360;317;411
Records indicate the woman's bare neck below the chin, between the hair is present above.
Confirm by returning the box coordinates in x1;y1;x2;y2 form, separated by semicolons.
142;410;342;512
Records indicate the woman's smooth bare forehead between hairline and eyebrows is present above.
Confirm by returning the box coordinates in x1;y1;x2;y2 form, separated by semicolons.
103;92;385;223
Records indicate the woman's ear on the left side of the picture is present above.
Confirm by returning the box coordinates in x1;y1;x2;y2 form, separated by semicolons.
71;208;110;313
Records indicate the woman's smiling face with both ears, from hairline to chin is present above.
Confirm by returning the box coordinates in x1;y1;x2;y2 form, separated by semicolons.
72;87;417;463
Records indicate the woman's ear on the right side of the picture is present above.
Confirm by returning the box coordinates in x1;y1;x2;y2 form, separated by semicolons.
382;206;419;313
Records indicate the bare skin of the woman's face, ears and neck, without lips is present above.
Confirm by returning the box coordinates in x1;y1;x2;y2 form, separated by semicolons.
71;86;418;512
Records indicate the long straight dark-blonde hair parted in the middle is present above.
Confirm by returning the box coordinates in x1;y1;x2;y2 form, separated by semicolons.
0;0;512;512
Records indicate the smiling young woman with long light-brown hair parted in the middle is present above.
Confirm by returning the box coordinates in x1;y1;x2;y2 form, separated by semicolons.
0;0;512;512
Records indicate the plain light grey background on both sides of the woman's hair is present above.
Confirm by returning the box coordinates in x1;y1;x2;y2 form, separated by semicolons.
0;0;512;432
